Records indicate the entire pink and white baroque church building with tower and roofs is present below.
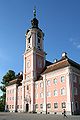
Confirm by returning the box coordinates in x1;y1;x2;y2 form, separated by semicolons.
5;10;80;115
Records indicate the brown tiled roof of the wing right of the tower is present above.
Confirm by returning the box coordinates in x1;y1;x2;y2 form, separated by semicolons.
42;58;80;74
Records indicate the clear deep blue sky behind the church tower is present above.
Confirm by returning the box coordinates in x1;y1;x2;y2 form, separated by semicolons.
0;0;80;95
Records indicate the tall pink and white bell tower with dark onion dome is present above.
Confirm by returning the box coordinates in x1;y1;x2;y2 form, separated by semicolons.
22;9;45;112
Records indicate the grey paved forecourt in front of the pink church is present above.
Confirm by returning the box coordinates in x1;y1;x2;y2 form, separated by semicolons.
0;113;80;120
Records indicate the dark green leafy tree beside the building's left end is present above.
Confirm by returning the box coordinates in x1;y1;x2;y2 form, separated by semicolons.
0;70;16;110
